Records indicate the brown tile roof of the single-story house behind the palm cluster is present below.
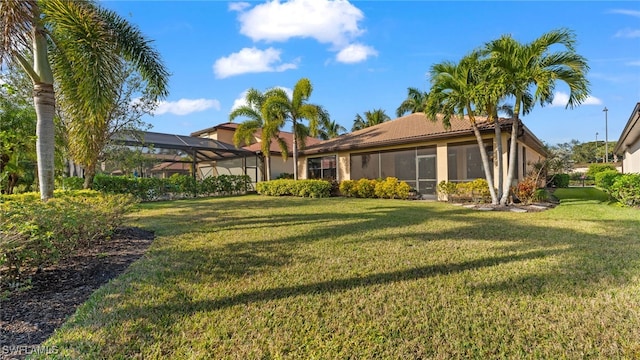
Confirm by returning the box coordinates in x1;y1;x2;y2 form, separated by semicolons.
304;113;498;154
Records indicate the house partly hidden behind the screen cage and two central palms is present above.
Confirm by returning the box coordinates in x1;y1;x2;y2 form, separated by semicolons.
191;122;321;180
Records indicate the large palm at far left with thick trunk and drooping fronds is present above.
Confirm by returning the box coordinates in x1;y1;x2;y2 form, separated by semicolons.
0;0;168;201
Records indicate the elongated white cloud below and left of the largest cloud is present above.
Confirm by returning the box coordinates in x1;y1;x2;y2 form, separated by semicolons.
213;47;299;79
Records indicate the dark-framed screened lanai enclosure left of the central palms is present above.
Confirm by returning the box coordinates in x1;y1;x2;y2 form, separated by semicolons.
113;131;262;187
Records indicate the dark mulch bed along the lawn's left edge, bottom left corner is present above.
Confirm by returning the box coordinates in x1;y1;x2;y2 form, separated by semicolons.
0;228;154;358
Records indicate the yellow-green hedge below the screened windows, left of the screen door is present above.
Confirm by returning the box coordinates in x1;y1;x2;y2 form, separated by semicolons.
340;177;411;199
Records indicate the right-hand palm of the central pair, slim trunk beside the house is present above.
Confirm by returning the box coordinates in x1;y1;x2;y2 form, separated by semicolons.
262;78;329;180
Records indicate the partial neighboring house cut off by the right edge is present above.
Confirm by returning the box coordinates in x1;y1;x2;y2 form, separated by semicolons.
613;102;640;174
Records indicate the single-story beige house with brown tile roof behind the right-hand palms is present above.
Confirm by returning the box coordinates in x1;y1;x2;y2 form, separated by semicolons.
298;113;546;197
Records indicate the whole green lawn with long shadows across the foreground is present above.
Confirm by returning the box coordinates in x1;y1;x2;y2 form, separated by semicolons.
38;188;640;359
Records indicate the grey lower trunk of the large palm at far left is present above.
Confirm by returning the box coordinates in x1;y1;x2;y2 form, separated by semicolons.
33;83;55;201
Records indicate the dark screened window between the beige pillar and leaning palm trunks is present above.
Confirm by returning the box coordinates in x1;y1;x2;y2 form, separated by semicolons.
447;143;493;181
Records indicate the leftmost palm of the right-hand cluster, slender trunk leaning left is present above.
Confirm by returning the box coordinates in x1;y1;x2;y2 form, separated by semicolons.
425;52;498;204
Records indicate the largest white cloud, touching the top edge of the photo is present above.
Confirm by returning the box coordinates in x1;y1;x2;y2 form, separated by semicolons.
238;0;364;48
